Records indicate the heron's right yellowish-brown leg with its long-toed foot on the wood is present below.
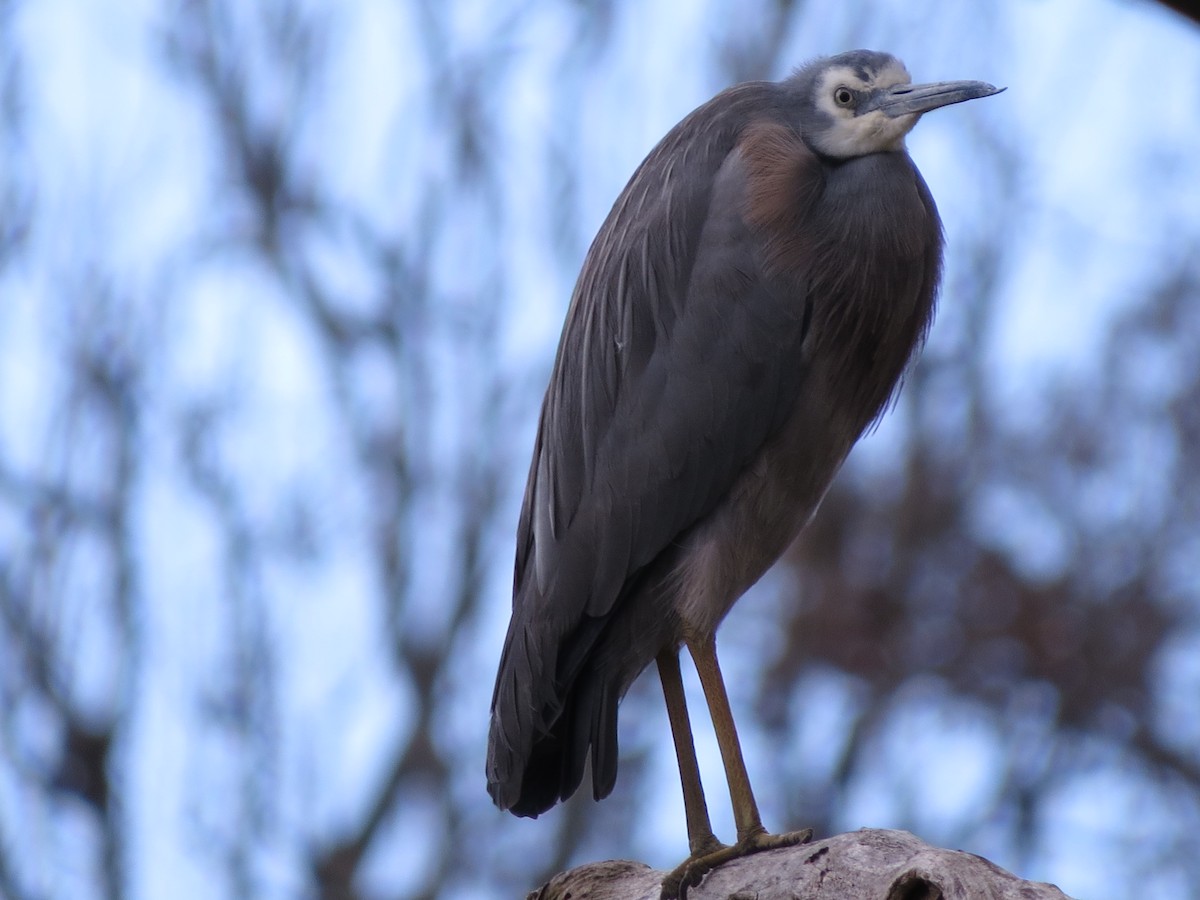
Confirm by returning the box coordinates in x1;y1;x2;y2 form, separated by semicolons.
662;638;812;898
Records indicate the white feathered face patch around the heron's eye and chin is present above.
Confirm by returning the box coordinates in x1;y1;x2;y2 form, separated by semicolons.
812;60;920;158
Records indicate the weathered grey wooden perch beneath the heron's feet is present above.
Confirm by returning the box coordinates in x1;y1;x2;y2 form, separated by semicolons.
527;828;1067;900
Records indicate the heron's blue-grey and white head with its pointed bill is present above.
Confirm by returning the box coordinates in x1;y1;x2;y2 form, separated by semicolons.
785;50;1003;158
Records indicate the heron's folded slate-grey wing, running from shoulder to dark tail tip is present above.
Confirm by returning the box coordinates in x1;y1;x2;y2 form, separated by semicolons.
488;84;820;815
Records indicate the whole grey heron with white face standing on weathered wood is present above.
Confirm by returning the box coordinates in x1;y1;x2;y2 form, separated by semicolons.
487;50;1002;898
